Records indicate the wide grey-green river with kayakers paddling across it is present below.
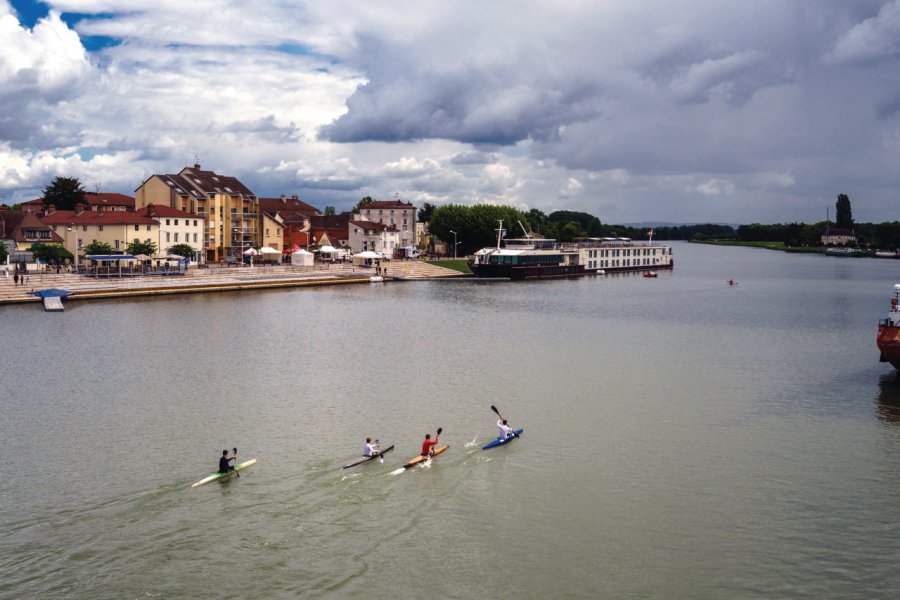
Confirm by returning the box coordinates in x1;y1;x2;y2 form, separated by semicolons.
0;243;900;599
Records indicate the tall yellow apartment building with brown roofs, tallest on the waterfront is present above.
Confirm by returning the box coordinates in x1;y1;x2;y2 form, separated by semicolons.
134;164;263;261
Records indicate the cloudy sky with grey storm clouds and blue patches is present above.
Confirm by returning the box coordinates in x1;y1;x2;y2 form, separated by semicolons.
0;0;900;223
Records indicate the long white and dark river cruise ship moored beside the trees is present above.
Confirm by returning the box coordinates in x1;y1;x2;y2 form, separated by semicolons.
469;223;674;279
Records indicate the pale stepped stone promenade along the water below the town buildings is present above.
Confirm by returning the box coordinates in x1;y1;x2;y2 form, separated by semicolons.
0;261;462;305
